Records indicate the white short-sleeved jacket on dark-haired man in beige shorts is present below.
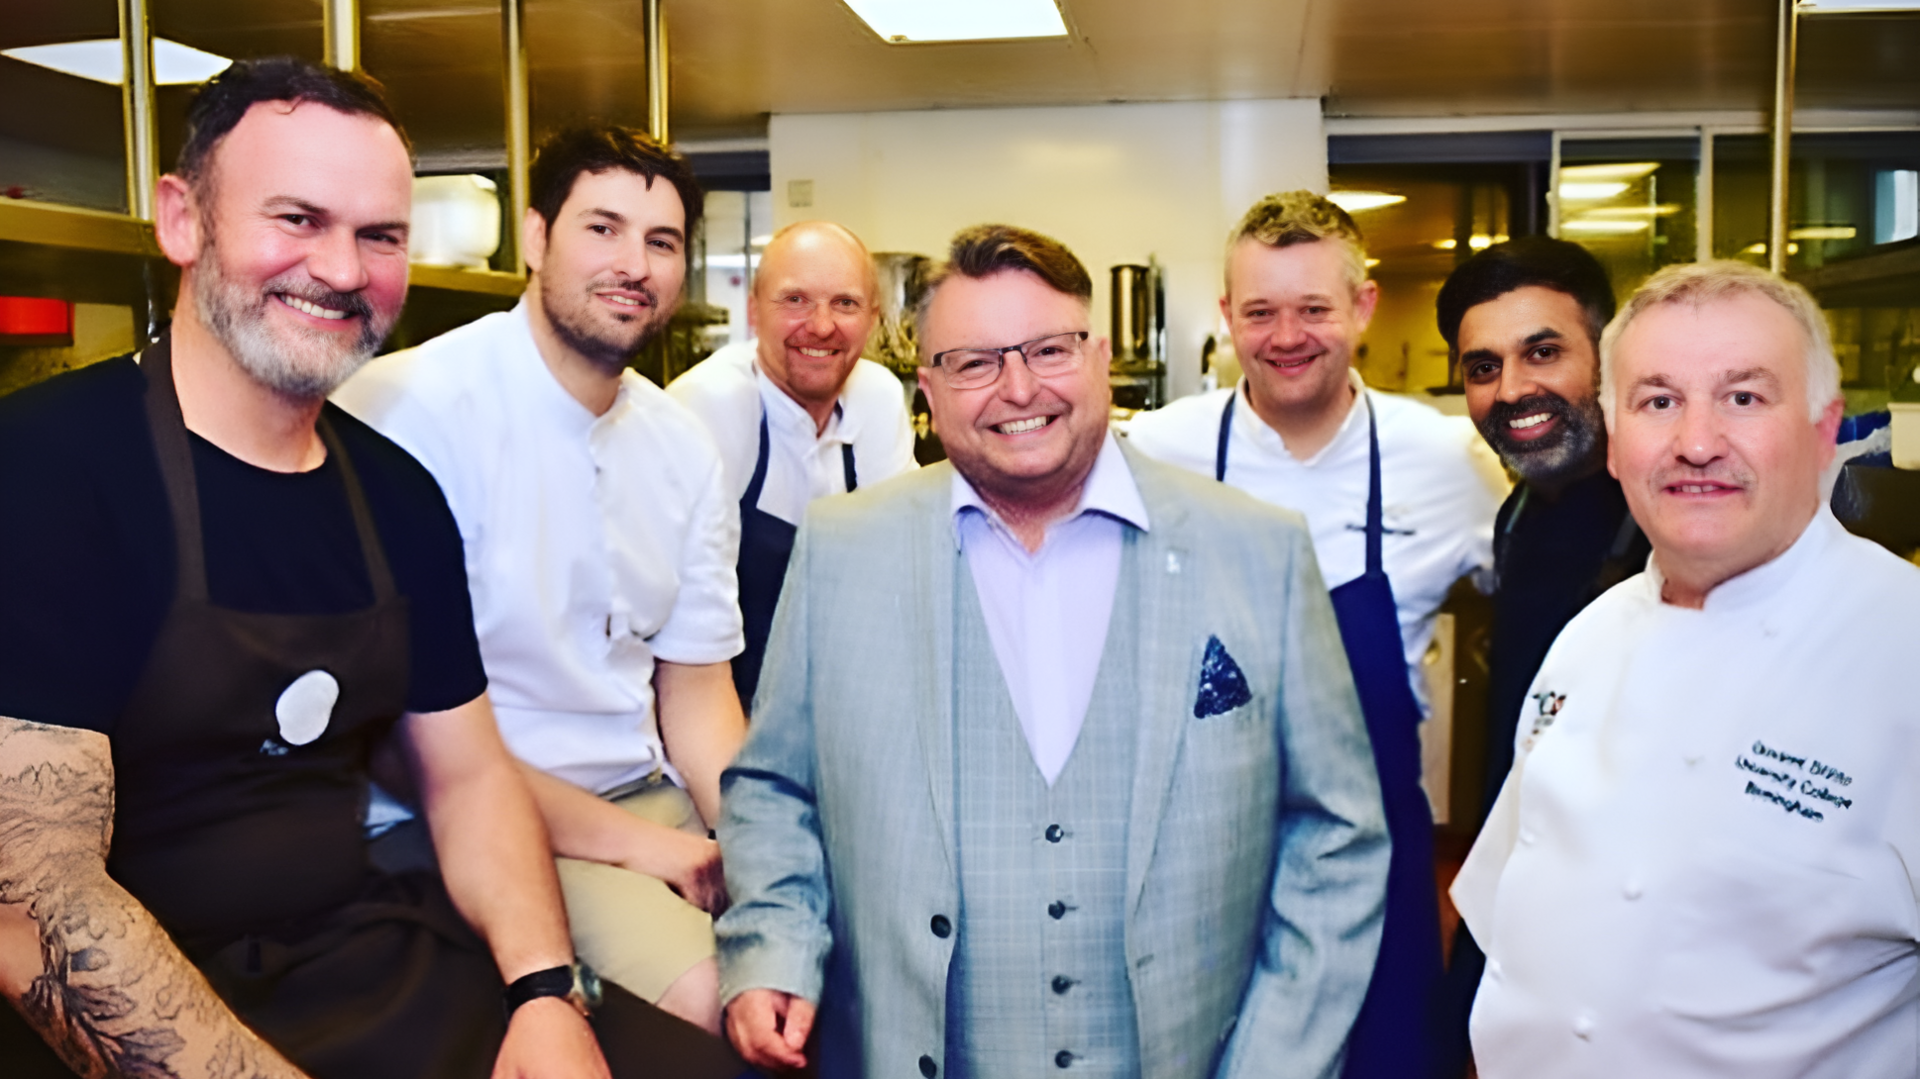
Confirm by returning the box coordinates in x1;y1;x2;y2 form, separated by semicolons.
334;301;745;791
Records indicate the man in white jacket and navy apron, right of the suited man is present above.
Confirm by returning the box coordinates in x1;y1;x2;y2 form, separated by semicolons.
1129;192;1501;1079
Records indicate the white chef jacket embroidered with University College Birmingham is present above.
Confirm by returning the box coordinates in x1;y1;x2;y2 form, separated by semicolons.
1453;509;1920;1079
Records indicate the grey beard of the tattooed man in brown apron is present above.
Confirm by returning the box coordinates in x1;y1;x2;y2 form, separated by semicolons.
194;242;394;401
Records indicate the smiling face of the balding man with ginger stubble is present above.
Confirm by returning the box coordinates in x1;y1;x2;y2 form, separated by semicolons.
747;223;879;419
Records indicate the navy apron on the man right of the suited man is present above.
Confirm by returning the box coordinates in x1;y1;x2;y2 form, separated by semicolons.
1213;392;1440;1079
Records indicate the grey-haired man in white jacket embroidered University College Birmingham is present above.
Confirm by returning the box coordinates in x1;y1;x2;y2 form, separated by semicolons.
1453;255;1920;1079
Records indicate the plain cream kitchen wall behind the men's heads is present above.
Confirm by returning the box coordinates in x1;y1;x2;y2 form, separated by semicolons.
768;100;1327;397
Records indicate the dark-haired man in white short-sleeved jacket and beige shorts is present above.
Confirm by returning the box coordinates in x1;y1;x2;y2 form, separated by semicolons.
336;125;745;1031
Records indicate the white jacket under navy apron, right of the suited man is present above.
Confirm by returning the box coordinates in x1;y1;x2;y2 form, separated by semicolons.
1125;374;1507;708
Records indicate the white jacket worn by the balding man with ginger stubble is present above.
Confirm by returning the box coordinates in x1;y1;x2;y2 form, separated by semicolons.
666;340;914;524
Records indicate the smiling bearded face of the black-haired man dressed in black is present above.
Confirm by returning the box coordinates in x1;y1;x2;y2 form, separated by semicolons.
1459;284;1605;488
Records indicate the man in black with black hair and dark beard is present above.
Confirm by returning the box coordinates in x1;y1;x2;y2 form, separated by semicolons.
1438;236;1649;1075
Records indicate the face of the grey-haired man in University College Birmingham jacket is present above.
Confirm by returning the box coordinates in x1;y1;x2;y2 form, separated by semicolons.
1607;294;1841;603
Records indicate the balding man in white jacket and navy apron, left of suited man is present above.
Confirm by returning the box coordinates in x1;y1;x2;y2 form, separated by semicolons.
666;221;914;707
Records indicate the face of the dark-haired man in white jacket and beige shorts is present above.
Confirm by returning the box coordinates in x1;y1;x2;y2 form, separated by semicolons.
522;169;687;371
